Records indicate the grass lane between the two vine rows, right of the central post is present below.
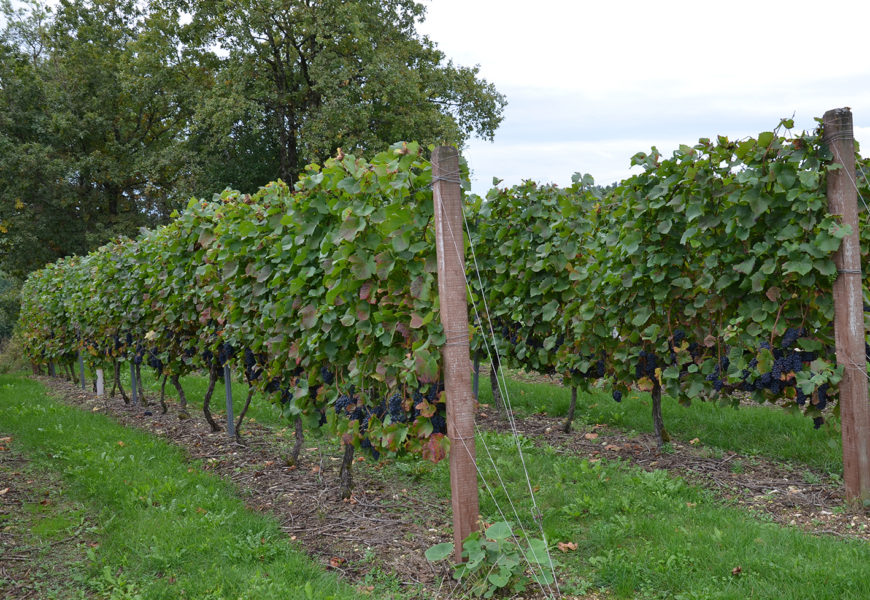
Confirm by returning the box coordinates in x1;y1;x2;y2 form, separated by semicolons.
393;433;870;600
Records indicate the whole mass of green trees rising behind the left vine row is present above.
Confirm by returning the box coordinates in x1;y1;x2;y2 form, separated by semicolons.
0;0;505;276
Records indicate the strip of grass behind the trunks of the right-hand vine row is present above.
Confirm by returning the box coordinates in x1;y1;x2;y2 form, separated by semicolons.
480;379;843;475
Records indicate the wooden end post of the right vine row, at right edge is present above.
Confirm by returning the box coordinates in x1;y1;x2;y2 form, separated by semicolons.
822;108;870;503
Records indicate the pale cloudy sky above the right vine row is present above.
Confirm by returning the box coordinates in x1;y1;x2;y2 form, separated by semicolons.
418;0;870;194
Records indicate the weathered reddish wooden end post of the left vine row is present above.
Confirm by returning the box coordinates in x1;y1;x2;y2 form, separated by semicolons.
432;146;478;562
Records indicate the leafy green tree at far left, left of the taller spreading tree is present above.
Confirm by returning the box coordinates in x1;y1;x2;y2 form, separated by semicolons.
0;0;210;275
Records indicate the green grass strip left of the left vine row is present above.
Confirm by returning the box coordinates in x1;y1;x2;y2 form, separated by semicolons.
0;375;358;600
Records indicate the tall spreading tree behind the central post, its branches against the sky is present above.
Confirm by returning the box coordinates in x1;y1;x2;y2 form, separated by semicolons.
182;0;505;187
